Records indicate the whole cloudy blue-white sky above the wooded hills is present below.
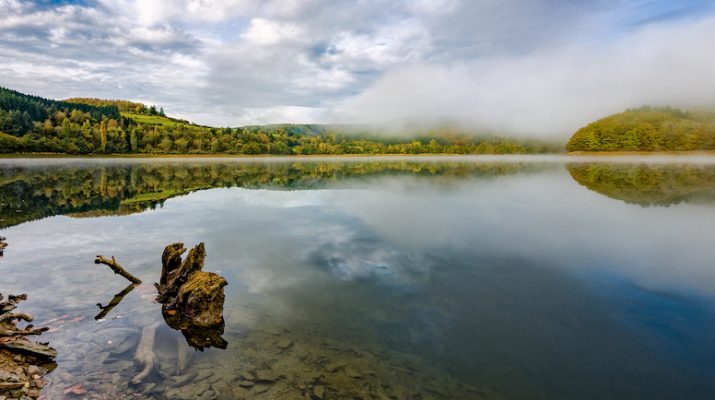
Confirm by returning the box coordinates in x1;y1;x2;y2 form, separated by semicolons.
0;0;715;137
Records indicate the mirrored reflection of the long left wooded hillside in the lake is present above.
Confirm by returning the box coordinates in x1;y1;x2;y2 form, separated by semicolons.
0;161;536;228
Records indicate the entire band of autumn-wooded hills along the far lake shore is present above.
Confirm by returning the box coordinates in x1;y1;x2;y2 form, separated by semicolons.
0;87;715;158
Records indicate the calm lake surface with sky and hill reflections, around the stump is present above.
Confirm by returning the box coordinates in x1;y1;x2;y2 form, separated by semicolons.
0;157;715;399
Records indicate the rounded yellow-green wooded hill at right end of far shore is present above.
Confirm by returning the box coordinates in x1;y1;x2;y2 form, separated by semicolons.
566;107;715;152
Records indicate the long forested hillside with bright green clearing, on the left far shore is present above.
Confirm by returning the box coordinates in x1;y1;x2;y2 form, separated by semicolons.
0;88;561;155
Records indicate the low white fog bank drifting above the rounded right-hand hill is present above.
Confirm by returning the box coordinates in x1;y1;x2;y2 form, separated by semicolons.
336;18;715;136
